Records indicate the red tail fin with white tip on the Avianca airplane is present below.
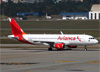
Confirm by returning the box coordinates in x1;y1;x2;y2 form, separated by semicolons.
9;18;26;36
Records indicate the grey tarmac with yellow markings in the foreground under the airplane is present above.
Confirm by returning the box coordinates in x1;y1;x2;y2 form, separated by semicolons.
0;45;100;72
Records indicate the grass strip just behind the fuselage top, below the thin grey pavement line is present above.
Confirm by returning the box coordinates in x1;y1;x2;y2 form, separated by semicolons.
0;30;99;37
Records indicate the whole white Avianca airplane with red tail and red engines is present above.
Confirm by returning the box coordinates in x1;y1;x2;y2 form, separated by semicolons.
8;18;98;51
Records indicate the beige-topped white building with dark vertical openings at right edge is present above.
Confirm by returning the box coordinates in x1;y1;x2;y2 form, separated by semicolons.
89;4;100;20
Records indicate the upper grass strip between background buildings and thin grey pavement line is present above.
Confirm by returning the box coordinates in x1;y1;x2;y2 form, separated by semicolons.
0;20;99;29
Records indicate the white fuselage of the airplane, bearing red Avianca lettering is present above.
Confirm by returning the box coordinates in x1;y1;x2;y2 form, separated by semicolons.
19;34;98;45
